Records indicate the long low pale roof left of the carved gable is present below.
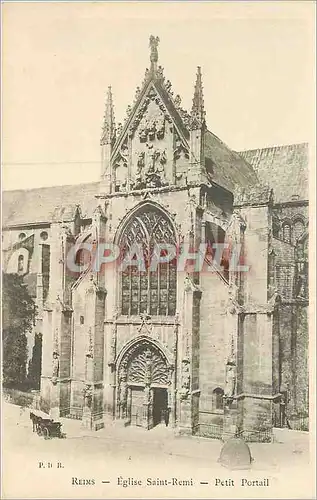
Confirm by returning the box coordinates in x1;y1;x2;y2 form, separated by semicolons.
2;182;99;227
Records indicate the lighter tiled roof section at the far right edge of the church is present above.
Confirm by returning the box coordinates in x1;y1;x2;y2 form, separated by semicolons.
239;143;308;203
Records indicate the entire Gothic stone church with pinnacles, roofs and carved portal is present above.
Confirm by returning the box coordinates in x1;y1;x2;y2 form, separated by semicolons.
3;36;308;440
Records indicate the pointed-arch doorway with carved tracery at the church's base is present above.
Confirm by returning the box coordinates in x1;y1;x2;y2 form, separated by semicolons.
117;340;172;430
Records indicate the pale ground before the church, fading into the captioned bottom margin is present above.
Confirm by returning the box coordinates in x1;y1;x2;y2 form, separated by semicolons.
2;403;314;498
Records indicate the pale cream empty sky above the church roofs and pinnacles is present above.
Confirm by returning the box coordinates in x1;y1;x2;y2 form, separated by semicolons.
2;1;315;190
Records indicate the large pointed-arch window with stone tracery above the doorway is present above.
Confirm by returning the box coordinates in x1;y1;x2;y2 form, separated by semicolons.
120;207;176;316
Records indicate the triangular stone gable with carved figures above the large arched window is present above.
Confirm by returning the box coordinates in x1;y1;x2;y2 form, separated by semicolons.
110;71;190;191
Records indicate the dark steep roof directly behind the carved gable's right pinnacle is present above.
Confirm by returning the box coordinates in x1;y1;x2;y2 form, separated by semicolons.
205;130;258;192
